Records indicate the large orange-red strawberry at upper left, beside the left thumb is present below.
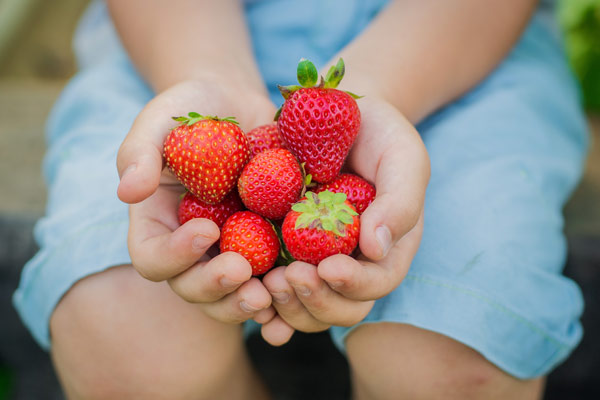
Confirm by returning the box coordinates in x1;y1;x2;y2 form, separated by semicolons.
164;112;250;204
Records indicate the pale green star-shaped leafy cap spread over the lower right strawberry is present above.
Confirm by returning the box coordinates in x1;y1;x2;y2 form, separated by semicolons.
292;190;358;236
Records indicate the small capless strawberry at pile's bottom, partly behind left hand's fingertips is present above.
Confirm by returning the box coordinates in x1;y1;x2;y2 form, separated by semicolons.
220;211;280;275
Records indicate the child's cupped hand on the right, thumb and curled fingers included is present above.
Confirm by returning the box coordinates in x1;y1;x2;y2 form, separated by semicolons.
262;98;429;344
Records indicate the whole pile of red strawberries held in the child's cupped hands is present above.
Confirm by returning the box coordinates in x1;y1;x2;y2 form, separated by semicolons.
164;59;375;275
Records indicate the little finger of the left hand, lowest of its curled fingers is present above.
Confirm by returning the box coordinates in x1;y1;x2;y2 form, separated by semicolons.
202;278;271;323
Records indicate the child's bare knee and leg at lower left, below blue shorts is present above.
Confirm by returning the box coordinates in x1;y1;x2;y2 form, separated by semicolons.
50;266;268;400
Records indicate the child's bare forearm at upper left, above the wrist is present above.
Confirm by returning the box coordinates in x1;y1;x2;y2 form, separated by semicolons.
107;0;265;92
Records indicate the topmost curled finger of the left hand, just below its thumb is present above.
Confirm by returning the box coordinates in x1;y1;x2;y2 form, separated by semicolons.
128;187;220;281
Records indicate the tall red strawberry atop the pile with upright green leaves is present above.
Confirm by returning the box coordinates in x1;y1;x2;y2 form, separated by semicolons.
276;58;360;183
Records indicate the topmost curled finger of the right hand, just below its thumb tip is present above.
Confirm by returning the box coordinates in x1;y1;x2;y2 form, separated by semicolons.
317;212;423;301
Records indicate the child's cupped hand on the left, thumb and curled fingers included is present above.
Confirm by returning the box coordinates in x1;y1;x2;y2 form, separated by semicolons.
117;81;275;322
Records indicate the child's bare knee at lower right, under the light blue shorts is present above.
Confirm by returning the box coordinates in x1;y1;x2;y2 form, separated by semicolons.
346;323;542;399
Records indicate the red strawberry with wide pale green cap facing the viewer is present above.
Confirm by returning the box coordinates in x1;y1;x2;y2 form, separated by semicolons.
281;190;360;265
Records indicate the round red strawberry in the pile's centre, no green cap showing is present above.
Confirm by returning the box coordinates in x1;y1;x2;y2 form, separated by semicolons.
238;149;303;220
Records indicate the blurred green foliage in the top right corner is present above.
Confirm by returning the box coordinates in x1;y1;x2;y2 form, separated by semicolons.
558;0;600;110
